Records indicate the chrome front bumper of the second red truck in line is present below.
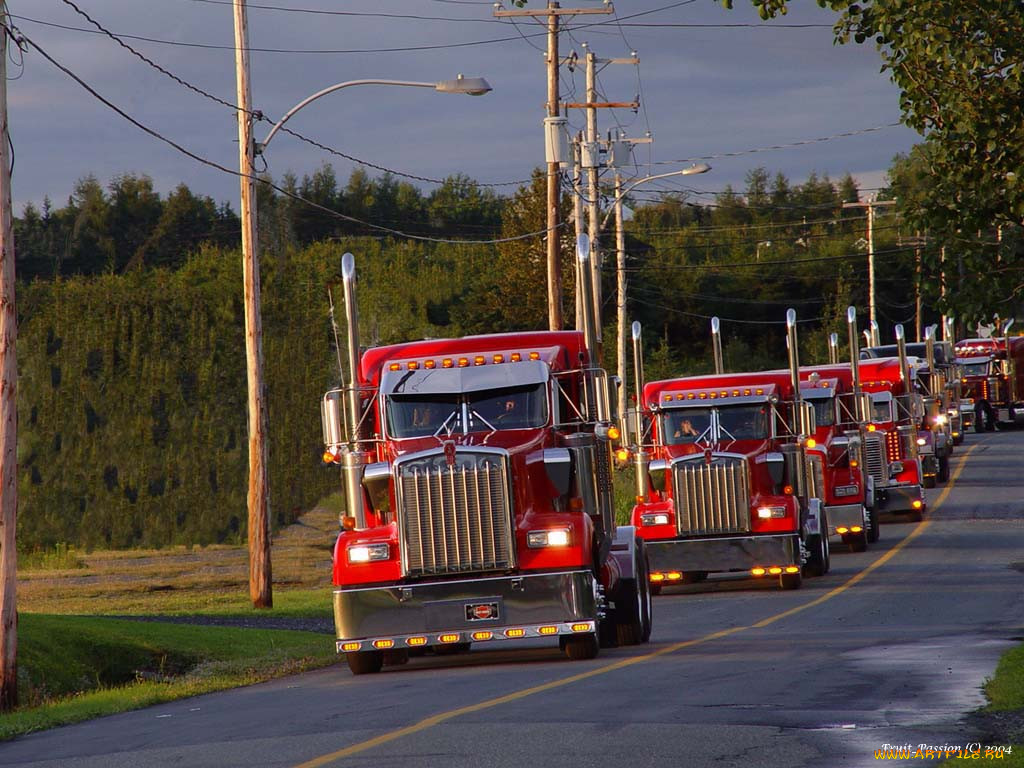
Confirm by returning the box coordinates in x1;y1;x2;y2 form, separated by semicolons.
647;534;801;573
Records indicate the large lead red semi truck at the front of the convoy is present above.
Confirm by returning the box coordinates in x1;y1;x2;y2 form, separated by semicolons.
323;239;651;674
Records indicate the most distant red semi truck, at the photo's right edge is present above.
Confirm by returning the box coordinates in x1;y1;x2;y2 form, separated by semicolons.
955;321;1024;432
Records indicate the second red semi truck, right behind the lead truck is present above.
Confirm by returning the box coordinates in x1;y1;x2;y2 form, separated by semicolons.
632;310;829;594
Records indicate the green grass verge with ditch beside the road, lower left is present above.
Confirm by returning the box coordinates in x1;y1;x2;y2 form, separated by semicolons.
6;613;337;739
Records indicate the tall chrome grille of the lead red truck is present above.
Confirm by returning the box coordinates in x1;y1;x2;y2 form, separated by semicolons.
396;451;515;577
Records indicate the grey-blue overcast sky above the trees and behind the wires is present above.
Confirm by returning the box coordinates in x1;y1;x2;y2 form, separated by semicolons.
7;0;918;215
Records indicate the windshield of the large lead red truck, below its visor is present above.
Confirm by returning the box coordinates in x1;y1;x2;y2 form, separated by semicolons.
387;384;548;438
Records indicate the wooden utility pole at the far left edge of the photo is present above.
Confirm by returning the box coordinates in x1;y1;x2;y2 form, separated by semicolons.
0;0;17;712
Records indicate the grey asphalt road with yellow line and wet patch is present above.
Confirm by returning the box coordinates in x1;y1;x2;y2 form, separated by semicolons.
0;432;1024;768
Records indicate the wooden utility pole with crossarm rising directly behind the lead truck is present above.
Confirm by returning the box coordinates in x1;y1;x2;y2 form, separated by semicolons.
495;0;614;331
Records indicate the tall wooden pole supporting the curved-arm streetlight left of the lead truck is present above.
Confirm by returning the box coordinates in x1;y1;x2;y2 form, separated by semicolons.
234;0;273;608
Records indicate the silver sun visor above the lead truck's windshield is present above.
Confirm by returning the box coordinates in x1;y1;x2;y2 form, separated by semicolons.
381;360;550;395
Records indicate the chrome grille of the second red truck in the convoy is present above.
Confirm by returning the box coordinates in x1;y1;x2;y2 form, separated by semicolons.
672;457;751;536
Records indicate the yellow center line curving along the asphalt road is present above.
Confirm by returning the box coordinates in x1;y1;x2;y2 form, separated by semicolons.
294;445;978;768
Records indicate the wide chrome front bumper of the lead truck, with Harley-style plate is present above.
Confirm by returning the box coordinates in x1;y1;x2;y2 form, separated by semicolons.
334;570;604;651
